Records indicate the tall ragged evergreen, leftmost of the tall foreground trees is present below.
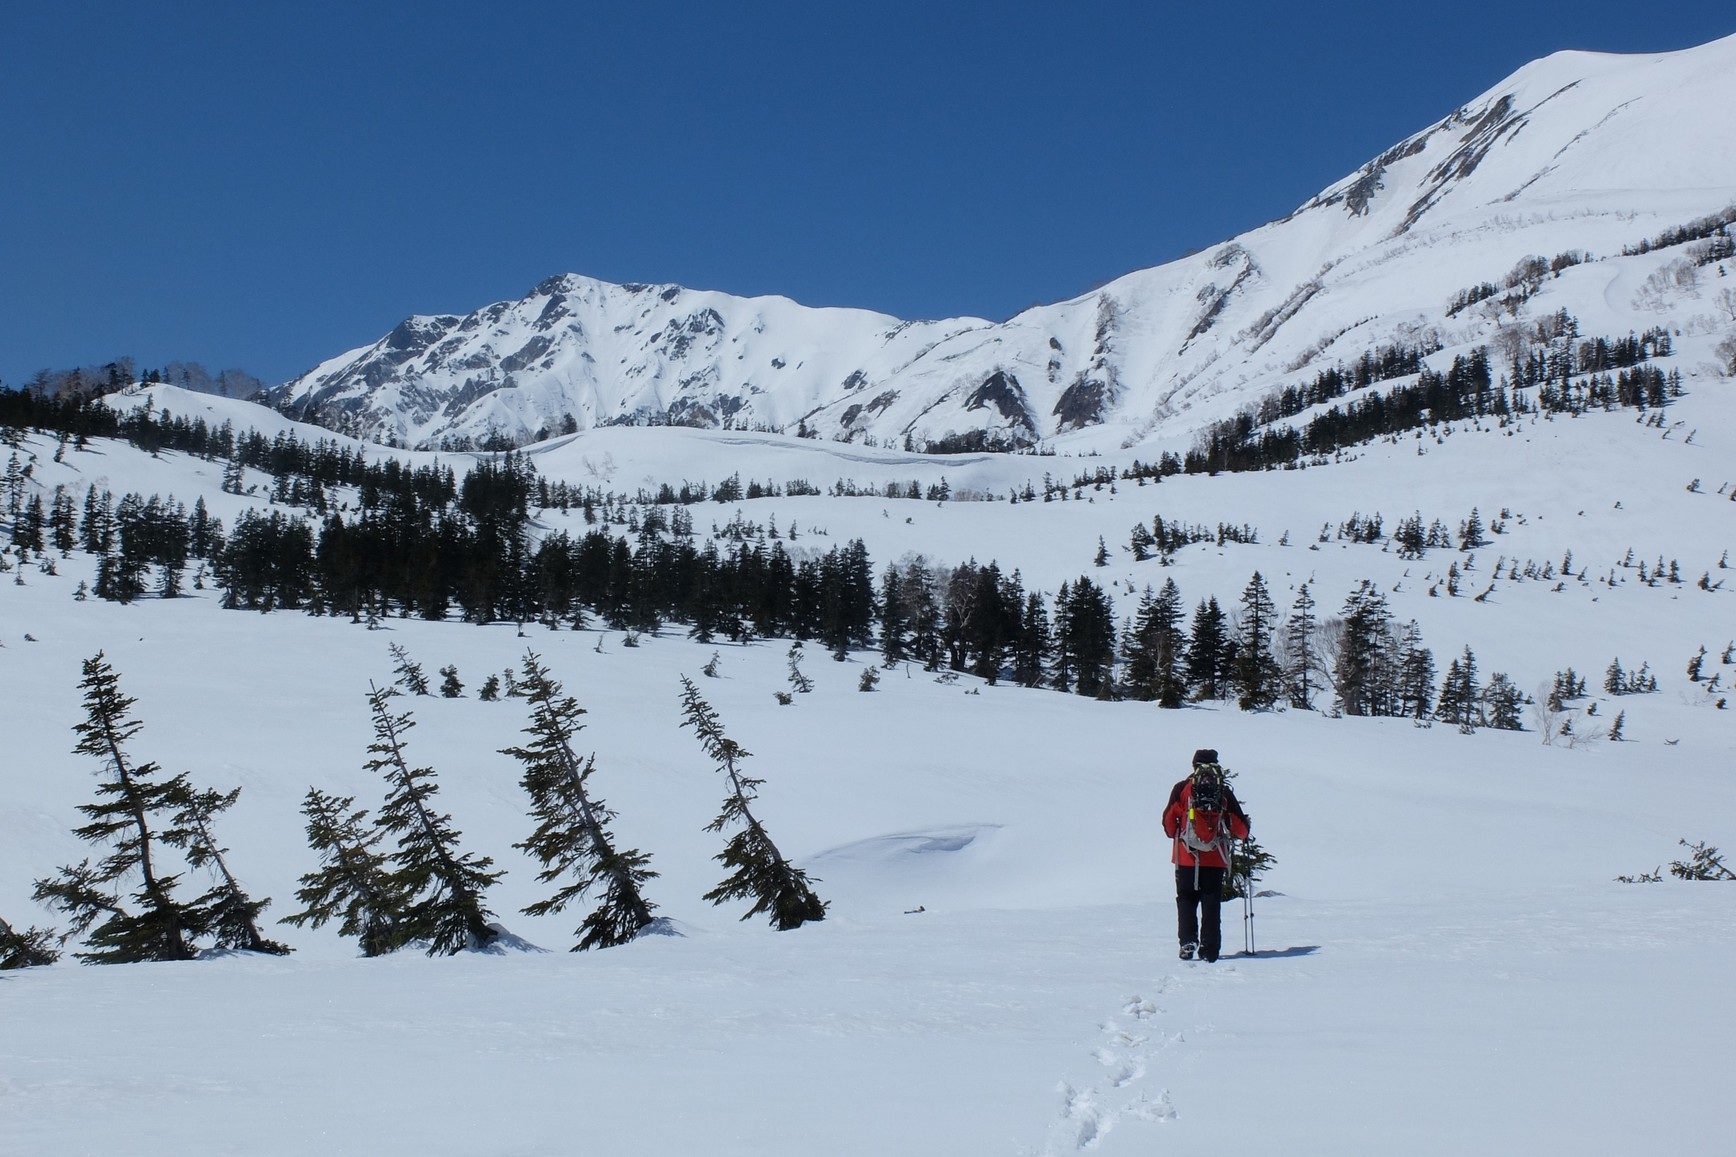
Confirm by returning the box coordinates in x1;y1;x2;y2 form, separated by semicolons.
33;651;205;964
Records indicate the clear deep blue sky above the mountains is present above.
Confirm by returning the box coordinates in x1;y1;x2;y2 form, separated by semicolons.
0;0;1736;386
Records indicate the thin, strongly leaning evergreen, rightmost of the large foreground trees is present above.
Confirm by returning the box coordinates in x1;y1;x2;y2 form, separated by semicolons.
681;678;826;931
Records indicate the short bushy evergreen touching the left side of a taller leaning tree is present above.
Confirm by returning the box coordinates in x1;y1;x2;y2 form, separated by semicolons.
283;787;408;955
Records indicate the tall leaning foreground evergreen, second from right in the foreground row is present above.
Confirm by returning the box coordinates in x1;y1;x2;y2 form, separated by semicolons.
502;651;659;952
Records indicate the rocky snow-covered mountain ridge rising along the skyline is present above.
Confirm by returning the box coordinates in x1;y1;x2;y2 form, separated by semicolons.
269;36;1736;450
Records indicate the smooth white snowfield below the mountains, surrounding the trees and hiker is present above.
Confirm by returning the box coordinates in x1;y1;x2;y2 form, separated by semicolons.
0;335;1736;1157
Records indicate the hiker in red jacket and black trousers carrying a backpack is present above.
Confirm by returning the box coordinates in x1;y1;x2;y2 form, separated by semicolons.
1163;747;1250;961
